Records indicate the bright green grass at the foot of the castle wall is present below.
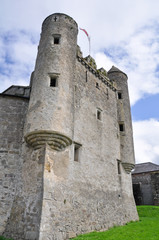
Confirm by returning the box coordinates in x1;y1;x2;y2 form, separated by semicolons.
73;206;159;240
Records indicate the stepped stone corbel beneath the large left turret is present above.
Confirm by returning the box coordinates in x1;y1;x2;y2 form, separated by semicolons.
24;130;72;151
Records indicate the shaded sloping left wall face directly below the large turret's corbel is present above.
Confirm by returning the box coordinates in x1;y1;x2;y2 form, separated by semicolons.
4;144;45;240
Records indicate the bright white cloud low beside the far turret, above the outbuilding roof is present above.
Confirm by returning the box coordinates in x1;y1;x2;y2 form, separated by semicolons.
133;119;159;164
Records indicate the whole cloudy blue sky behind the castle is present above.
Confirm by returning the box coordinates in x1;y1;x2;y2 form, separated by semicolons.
0;0;159;164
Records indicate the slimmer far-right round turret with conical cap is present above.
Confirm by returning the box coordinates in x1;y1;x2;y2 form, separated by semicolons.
108;66;135;173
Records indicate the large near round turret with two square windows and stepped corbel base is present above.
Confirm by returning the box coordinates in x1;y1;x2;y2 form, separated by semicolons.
25;13;78;150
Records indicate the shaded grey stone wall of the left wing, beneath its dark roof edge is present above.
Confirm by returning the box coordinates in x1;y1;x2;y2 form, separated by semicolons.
0;95;28;234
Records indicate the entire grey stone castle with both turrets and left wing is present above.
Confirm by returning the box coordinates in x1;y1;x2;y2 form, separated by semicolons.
0;13;138;240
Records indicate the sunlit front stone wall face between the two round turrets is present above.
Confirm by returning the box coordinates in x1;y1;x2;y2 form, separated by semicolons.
37;54;138;240
